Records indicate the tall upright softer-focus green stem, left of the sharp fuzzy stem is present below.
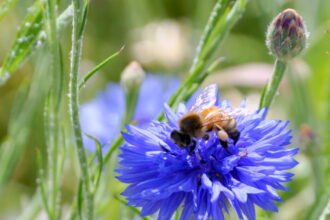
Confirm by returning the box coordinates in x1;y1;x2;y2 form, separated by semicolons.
45;0;64;219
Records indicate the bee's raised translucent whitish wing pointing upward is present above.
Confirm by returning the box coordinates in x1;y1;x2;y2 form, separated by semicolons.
190;84;218;112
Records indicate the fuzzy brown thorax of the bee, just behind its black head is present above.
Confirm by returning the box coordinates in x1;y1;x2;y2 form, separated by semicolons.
179;112;204;138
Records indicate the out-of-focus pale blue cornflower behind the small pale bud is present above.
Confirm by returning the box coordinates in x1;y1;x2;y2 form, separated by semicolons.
80;74;180;151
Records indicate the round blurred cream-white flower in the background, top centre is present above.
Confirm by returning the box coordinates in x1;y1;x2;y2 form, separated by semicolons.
132;20;190;68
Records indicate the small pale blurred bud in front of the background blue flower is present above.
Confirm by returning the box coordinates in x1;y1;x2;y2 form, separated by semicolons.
120;61;145;90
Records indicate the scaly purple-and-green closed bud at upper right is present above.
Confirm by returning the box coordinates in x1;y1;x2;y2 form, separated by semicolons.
266;9;307;60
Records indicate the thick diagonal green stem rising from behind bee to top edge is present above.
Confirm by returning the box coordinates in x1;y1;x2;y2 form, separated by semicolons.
158;0;248;120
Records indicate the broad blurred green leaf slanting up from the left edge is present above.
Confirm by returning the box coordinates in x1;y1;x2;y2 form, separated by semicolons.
0;51;50;189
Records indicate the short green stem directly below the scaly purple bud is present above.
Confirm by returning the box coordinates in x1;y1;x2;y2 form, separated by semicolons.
259;59;287;109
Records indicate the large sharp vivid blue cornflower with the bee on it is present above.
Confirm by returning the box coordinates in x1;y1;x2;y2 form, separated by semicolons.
117;85;298;220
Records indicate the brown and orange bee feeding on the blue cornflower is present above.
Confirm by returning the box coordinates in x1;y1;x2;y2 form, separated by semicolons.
171;84;240;151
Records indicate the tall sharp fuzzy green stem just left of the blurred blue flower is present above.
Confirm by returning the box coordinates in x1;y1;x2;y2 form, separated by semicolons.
68;0;94;219
